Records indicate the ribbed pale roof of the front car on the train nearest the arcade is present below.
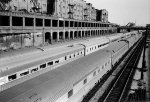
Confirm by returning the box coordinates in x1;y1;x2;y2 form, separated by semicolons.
0;45;83;76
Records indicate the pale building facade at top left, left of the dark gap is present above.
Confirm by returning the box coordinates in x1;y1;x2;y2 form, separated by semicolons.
0;0;47;13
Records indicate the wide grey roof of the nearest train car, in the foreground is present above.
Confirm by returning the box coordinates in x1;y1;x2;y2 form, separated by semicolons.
0;47;111;102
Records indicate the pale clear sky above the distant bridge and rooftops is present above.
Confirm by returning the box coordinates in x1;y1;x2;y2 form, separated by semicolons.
85;0;150;26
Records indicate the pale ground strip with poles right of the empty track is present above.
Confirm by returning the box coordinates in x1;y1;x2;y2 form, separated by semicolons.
129;36;150;102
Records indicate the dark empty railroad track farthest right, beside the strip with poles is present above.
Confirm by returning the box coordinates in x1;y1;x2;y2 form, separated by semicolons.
98;35;143;102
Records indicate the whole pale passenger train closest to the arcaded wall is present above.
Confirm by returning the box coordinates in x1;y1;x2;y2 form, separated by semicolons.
0;32;141;91
